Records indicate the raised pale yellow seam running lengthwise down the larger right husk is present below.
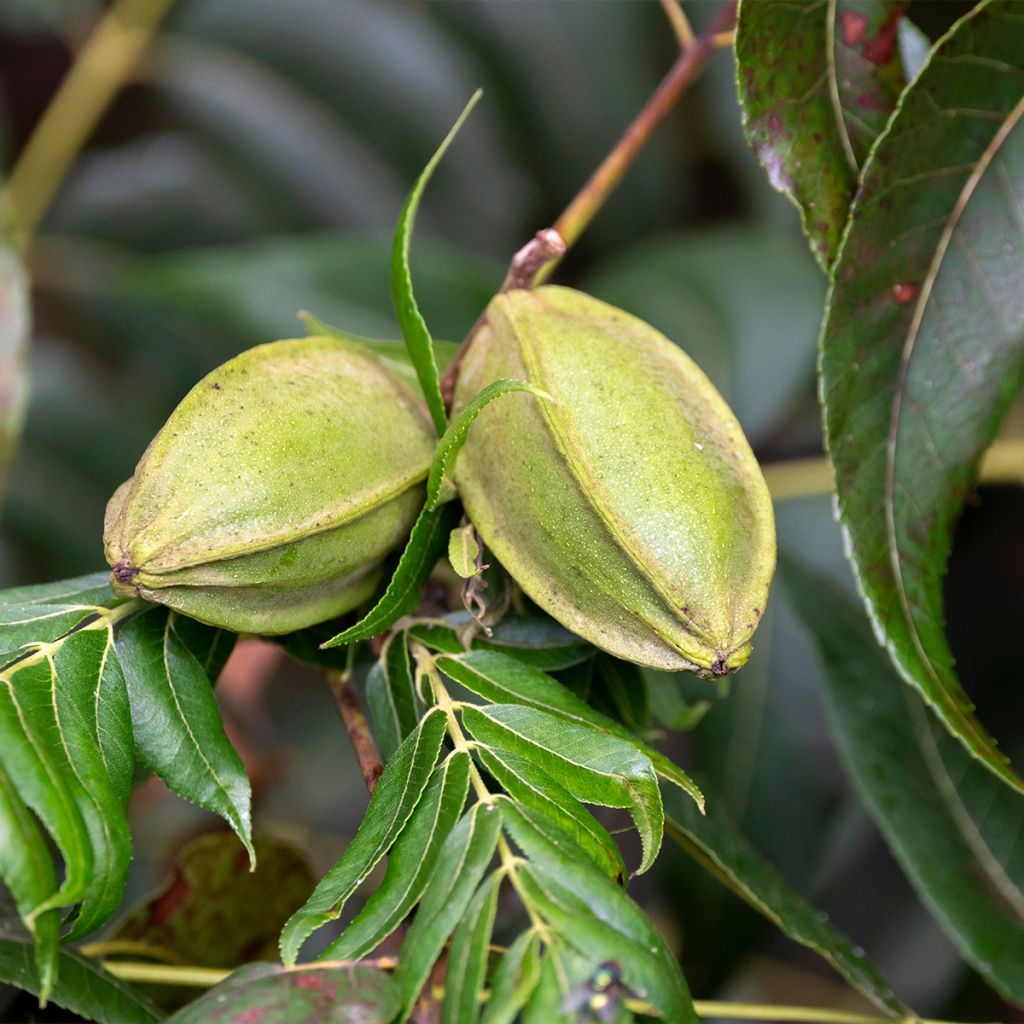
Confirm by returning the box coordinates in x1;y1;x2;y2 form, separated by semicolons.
496;293;750;669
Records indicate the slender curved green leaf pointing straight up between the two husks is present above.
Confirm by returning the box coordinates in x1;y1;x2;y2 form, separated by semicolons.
391;90;481;435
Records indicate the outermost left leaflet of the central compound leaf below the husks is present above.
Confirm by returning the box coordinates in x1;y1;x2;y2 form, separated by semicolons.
281;708;445;966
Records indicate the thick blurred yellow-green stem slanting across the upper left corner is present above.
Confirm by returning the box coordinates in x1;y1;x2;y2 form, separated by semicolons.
6;0;173;249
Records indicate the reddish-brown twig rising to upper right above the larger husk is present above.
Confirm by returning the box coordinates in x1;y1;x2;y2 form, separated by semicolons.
534;0;736;284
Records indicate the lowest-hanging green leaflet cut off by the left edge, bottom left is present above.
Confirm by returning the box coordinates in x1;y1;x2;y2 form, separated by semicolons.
0;767;60;1000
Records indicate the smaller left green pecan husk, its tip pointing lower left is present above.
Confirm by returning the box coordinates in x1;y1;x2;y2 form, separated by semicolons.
104;337;436;634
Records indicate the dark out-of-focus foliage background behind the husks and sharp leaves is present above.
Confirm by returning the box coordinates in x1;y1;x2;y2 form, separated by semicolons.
0;0;1024;1021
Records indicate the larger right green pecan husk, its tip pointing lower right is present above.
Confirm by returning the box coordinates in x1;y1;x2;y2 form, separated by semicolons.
455;287;775;676
